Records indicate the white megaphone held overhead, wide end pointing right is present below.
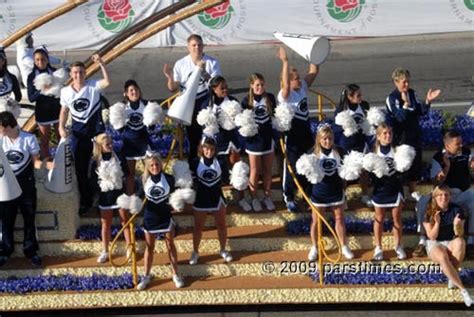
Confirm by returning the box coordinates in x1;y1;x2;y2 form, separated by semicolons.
273;32;331;65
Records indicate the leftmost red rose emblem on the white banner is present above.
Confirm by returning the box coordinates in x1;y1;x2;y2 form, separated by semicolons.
97;0;135;33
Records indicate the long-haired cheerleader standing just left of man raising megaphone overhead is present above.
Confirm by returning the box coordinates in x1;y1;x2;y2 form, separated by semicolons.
242;73;275;211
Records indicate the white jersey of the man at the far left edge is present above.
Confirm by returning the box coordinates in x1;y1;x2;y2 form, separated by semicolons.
0;131;39;175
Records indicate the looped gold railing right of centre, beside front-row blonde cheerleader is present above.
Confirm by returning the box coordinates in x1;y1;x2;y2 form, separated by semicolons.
280;138;341;286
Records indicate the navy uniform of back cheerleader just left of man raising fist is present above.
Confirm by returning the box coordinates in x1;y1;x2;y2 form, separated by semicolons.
27;65;61;125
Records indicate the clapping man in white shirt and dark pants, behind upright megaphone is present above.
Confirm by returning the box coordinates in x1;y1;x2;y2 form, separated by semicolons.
163;34;221;162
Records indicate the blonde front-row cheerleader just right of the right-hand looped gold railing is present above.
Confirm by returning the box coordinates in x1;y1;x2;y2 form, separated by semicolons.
306;124;354;261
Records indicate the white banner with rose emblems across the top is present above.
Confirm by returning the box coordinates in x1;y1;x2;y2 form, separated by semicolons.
0;0;474;50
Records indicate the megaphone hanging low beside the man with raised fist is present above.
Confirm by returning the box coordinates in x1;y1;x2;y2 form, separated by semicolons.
44;139;72;193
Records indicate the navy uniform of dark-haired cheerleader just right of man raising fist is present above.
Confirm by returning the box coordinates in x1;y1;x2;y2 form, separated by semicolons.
122;99;149;160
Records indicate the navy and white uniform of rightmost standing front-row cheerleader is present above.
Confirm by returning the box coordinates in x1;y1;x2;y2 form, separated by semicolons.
372;145;404;208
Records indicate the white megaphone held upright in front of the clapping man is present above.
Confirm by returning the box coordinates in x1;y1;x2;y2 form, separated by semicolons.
168;66;201;125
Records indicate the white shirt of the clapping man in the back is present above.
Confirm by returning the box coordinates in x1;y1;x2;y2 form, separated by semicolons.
173;55;221;99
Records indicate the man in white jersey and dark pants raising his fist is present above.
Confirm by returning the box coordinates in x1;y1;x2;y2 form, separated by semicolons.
59;55;110;214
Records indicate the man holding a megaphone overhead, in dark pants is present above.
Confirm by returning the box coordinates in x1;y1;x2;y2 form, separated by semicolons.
278;47;319;212
